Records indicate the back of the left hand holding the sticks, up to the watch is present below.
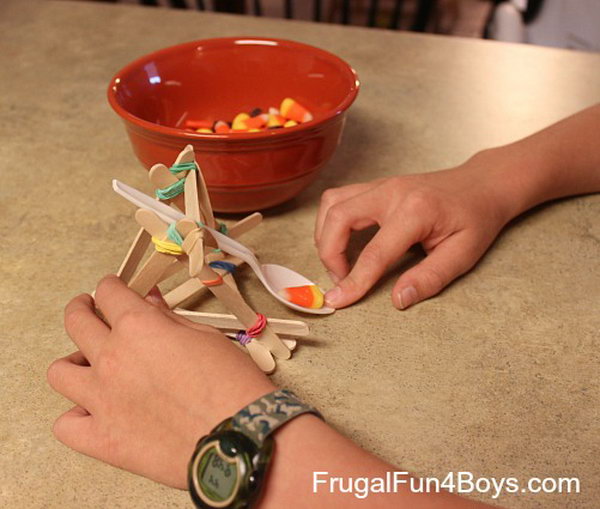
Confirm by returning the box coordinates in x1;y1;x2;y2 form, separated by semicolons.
48;276;274;488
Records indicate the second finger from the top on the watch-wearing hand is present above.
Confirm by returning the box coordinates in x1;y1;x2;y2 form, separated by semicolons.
64;294;110;361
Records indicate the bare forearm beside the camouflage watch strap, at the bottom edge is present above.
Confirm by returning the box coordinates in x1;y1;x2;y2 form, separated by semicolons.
260;415;486;509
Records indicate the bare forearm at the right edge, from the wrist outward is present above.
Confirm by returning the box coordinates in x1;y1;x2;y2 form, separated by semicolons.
465;104;600;219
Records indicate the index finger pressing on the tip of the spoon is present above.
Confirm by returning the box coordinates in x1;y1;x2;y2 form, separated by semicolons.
325;221;420;308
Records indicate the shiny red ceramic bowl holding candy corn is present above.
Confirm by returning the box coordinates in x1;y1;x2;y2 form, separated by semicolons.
108;37;359;212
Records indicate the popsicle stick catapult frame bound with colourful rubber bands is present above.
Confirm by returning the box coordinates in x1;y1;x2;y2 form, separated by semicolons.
113;145;309;373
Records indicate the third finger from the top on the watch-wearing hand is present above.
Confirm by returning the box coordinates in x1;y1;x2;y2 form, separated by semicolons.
47;352;94;408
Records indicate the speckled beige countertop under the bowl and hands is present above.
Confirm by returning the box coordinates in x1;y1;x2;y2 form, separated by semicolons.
0;0;600;509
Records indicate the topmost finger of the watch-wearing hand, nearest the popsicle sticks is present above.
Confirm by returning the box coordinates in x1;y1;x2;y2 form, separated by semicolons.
94;274;149;326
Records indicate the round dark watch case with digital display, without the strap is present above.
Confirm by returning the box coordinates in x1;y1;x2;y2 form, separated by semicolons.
188;419;273;509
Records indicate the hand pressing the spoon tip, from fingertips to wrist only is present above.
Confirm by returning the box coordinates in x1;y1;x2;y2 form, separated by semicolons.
315;157;511;309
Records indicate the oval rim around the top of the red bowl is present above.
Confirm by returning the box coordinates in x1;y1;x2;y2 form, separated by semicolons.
107;36;360;142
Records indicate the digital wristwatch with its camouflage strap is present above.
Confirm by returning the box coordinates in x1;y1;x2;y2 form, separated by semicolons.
188;389;322;509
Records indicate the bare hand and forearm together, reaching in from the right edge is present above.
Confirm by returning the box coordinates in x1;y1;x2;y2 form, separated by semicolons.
315;104;600;309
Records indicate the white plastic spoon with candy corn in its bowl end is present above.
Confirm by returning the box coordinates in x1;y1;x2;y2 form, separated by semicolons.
113;180;335;315
